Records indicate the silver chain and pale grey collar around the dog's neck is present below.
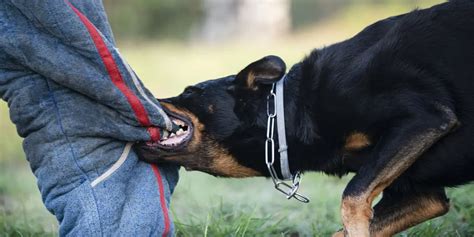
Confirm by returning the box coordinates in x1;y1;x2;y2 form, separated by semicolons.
265;76;309;203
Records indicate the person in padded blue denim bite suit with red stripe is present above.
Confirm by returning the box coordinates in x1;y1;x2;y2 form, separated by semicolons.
0;0;178;236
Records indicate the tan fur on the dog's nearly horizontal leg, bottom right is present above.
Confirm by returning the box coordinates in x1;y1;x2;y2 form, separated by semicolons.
370;197;449;237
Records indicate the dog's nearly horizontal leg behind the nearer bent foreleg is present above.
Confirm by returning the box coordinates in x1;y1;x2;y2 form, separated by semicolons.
370;189;449;237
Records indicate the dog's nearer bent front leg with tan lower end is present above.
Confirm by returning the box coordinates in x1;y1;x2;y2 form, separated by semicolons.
341;107;458;237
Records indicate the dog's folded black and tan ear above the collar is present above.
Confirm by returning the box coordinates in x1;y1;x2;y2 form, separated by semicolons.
235;55;286;90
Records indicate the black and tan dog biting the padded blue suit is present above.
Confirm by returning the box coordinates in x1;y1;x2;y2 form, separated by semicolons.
138;0;474;237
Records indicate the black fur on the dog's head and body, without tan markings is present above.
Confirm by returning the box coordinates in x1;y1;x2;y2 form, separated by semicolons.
137;0;474;235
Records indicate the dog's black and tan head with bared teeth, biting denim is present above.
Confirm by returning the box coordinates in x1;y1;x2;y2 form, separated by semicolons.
137;56;308;177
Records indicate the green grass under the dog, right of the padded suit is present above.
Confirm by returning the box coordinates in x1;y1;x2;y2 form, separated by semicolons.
172;173;474;236
